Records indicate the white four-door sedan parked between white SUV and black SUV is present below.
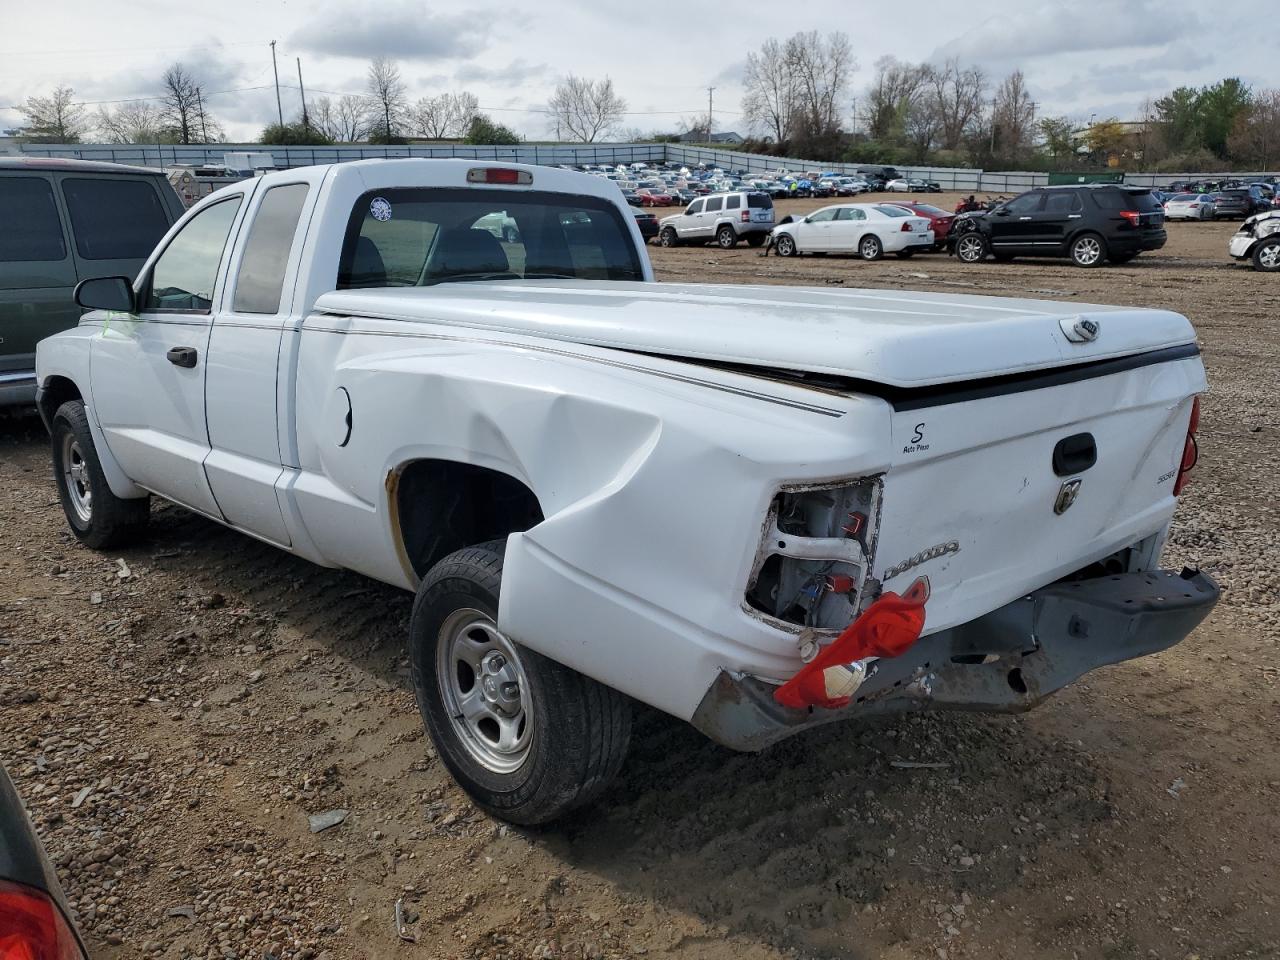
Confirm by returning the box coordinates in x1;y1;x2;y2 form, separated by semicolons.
773;204;933;260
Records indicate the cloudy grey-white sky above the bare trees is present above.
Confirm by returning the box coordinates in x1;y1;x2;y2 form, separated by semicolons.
0;0;1276;140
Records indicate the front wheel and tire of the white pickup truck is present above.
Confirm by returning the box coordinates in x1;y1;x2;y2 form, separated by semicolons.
52;401;151;550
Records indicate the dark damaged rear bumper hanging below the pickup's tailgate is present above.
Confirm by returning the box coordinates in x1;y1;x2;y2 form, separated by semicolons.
692;570;1219;750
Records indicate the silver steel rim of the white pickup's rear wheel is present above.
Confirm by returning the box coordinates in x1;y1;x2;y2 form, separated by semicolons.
435;608;534;773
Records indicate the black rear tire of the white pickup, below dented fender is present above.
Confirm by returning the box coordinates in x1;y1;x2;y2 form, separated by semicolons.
410;540;631;826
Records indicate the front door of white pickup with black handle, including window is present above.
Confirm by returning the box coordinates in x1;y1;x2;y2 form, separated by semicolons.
91;189;253;518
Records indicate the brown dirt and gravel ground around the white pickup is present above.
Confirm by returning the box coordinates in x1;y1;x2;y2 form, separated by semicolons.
0;197;1280;960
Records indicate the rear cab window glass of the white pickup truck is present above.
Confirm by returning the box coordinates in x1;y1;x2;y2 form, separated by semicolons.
337;187;644;289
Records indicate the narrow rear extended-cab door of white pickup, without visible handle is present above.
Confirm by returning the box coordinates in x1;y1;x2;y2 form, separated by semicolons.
205;170;324;547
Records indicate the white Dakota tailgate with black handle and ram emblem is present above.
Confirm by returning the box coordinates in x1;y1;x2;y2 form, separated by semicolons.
872;356;1206;634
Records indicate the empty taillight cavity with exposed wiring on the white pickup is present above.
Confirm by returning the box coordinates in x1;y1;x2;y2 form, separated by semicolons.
746;477;881;632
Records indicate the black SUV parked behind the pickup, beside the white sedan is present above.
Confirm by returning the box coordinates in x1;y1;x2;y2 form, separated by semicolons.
948;183;1167;266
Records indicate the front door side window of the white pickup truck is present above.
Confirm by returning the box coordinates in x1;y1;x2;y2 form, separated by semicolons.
141;195;243;314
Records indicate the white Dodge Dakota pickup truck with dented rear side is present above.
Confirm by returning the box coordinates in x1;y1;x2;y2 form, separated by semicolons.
37;160;1217;823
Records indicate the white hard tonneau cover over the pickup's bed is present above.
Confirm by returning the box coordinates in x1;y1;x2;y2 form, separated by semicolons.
316;280;1196;388
